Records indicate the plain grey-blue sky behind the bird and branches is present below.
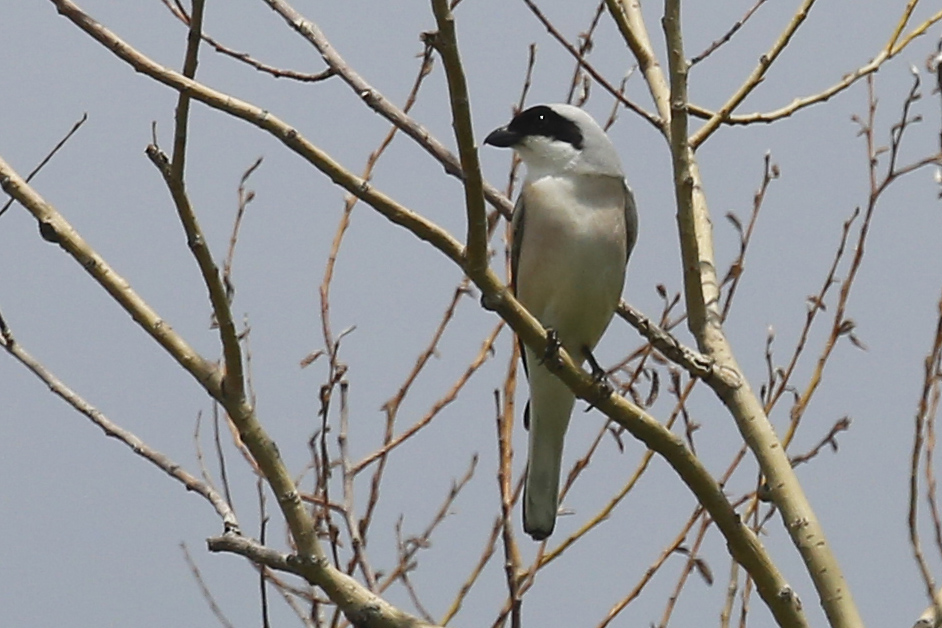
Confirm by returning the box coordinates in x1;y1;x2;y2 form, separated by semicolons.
0;0;942;626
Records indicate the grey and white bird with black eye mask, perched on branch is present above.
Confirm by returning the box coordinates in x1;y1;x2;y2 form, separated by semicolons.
484;104;638;541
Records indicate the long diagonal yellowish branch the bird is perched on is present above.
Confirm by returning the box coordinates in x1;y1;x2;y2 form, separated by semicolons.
33;0;888;619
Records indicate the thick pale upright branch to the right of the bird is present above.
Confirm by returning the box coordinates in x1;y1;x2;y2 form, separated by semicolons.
663;0;844;626
